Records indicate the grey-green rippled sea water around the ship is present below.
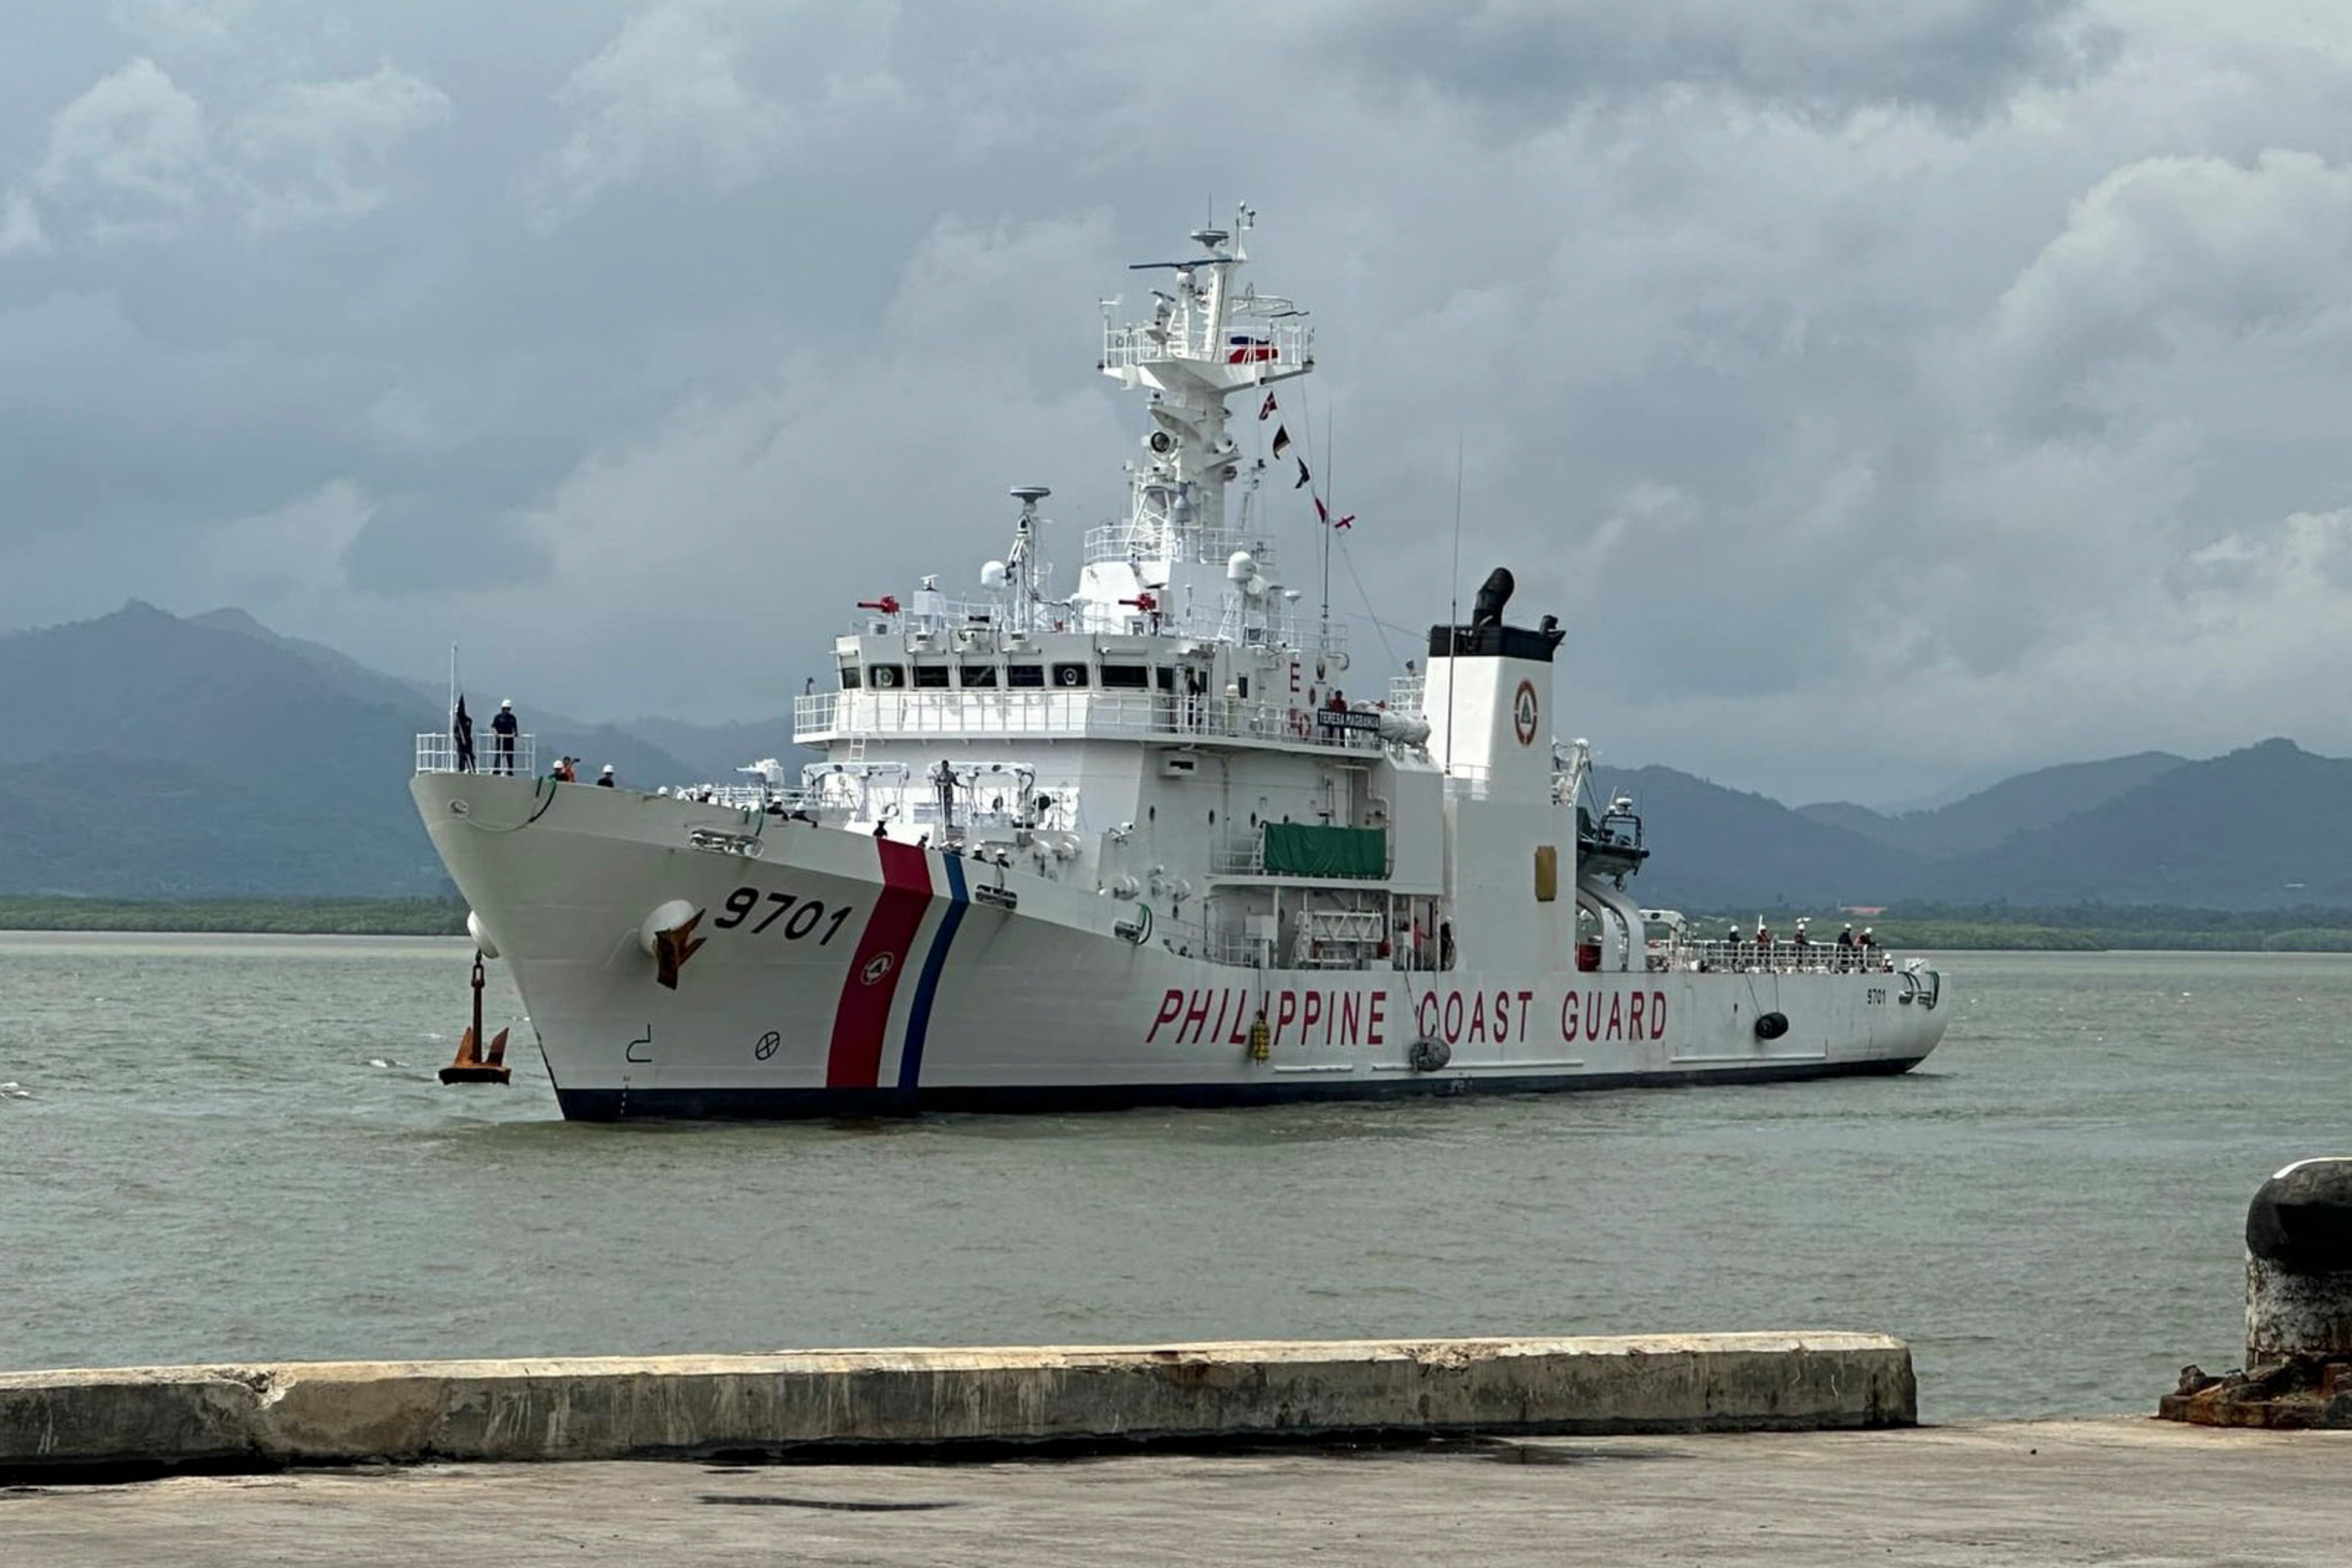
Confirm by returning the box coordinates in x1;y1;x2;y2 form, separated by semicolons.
0;933;2352;1420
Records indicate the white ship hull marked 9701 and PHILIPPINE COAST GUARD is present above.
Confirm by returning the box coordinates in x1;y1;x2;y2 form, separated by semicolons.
414;774;1945;1119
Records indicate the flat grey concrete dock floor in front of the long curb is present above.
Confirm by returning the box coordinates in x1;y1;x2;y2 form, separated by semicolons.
0;1420;2352;1568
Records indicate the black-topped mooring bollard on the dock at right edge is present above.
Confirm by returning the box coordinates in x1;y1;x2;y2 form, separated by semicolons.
2157;1159;2352;1427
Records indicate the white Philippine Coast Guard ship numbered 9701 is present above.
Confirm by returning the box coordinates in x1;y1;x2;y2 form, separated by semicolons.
412;210;1945;1119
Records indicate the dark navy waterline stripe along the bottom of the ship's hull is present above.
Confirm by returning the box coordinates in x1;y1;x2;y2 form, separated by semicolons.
555;1058;1920;1121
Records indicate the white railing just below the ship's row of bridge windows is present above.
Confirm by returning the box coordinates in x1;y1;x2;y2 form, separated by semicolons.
793;689;1381;752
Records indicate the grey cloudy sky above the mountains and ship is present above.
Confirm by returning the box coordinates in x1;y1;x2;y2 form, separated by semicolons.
0;0;2352;804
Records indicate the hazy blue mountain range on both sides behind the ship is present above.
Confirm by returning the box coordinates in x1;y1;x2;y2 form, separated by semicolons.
0;602;2352;912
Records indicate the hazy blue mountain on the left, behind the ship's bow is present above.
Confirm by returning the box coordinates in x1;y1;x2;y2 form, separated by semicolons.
0;602;696;898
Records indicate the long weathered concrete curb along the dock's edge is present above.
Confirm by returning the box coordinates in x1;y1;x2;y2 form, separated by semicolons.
0;1333;1917;1476
